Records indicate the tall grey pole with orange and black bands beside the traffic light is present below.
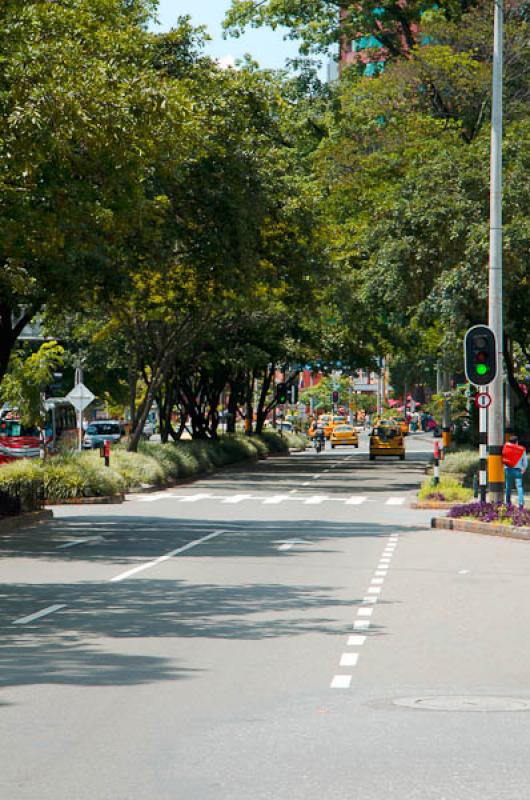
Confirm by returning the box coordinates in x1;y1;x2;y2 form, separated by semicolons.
488;0;504;503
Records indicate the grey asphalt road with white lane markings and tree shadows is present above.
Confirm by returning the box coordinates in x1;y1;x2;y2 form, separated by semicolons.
0;436;530;800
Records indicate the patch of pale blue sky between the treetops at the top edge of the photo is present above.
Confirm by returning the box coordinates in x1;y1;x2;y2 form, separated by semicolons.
153;0;297;68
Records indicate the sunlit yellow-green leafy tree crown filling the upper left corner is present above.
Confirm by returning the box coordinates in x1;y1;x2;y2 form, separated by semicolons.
0;0;190;388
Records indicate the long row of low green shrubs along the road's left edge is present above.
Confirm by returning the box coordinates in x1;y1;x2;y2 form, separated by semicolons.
0;431;306;503
